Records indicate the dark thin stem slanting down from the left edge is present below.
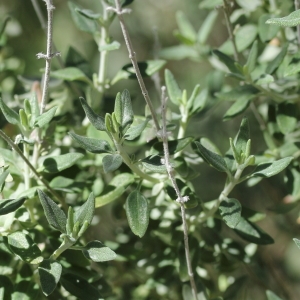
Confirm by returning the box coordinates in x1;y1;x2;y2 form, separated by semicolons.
0;130;66;208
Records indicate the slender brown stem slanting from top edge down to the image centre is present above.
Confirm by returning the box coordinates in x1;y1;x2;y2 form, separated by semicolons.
107;0;160;132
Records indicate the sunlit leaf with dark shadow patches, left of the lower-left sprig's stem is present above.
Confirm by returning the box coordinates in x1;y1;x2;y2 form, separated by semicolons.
7;231;43;264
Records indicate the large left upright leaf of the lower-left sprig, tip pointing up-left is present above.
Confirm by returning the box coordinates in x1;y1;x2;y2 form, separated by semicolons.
37;190;67;233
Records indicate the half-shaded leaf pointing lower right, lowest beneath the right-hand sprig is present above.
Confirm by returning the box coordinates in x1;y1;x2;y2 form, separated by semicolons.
233;217;274;245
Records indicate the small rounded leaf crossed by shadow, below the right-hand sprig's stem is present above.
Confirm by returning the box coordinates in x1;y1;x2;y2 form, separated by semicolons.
219;198;242;228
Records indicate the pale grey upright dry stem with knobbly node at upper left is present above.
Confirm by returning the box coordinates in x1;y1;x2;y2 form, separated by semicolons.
37;0;60;114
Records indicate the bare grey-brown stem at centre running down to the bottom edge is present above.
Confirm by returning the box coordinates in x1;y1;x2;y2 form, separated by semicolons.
158;86;198;300
